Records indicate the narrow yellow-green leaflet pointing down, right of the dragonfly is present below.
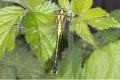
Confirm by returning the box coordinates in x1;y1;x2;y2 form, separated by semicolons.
70;18;95;46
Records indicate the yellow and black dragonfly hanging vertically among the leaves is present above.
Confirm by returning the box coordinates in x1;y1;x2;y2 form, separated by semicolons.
52;8;66;75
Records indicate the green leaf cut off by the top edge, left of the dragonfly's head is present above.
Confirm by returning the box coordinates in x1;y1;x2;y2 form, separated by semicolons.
19;0;58;14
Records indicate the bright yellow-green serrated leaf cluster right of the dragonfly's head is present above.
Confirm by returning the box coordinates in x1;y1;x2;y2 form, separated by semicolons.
59;0;120;46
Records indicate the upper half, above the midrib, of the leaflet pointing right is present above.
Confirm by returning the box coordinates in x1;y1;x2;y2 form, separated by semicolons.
84;7;109;20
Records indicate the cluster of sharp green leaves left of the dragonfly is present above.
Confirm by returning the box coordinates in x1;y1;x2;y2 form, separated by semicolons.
0;0;58;62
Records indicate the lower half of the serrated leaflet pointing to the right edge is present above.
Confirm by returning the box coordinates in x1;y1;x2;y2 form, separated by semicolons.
88;17;120;30
